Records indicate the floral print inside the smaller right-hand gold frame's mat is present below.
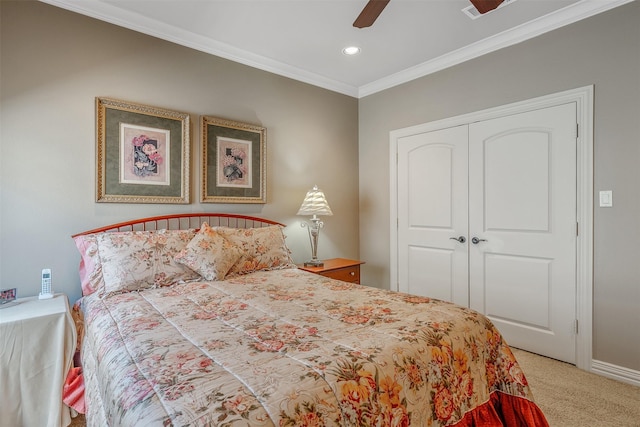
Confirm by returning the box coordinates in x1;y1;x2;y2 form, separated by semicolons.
216;138;251;188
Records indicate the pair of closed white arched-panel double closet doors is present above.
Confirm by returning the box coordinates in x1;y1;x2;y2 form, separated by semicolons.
397;103;577;363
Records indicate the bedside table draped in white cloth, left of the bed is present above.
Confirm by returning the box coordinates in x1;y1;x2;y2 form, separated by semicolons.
0;294;76;427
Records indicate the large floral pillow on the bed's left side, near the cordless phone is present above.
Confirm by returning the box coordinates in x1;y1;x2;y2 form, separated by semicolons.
96;230;200;296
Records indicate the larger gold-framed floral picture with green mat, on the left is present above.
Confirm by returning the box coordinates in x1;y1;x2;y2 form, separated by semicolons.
96;98;191;203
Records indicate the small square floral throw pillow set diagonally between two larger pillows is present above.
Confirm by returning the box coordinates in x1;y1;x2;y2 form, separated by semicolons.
174;222;242;280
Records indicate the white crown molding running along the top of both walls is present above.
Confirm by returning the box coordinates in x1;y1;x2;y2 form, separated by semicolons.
40;0;635;98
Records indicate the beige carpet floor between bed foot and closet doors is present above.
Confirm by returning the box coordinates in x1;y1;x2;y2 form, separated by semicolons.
513;349;640;427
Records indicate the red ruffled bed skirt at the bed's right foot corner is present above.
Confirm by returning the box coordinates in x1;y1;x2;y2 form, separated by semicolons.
454;392;549;427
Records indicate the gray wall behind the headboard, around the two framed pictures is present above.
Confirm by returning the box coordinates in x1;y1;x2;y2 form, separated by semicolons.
0;0;359;302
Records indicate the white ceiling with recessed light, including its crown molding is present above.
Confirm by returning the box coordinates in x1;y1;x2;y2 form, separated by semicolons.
41;0;633;97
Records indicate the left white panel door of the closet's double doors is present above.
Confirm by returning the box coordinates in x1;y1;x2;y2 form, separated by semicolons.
397;126;469;306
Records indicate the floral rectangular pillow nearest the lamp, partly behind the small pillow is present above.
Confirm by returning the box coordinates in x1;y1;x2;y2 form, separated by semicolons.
216;225;296;276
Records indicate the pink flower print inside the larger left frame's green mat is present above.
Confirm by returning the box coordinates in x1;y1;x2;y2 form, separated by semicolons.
120;123;171;185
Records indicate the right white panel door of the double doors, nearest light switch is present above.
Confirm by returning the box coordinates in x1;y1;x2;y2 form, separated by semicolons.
469;103;577;363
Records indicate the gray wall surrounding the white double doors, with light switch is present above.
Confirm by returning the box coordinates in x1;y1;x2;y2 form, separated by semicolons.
359;2;640;371
